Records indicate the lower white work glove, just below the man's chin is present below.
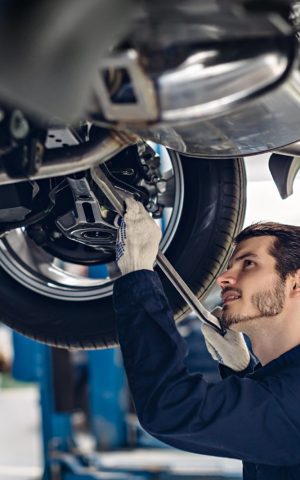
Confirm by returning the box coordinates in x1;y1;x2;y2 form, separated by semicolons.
201;308;250;372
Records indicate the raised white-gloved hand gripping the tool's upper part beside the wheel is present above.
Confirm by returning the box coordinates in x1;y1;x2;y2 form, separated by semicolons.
116;198;162;275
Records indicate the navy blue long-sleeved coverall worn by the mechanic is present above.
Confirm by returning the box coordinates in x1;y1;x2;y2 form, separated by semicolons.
114;270;300;480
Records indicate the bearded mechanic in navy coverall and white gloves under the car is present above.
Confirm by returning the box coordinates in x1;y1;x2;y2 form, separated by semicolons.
114;199;300;480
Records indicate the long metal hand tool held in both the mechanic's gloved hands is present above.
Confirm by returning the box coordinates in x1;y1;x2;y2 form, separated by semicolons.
91;166;226;336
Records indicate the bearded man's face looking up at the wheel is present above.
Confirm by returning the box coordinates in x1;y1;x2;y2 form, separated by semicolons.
217;236;286;330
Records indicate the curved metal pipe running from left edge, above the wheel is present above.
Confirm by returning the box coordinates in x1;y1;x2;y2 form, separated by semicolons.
0;132;138;185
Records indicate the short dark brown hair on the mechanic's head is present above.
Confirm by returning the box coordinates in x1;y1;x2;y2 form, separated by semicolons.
234;222;300;280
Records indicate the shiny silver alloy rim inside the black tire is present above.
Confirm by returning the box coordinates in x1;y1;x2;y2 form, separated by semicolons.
0;148;184;301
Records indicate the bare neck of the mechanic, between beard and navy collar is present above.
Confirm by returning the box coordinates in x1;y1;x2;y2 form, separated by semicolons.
242;317;300;365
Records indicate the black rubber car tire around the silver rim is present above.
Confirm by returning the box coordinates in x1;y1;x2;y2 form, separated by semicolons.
0;152;246;349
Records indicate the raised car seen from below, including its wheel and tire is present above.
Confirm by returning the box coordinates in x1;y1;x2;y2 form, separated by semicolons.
0;0;300;348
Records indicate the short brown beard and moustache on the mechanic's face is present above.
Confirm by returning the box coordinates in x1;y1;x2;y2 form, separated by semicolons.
220;279;285;329
